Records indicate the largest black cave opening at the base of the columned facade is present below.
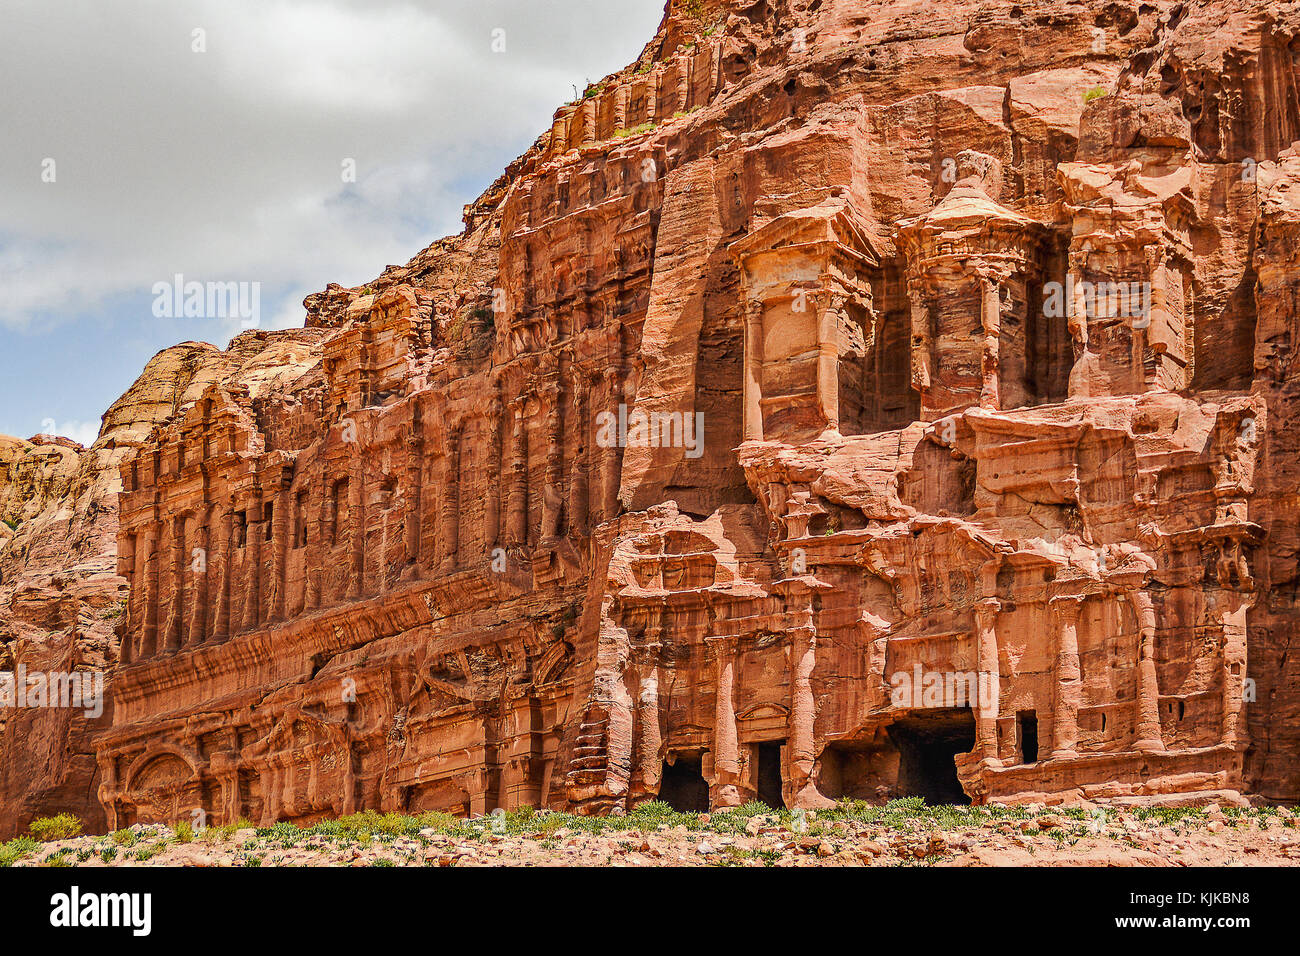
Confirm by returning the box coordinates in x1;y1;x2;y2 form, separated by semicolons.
888;708;975;805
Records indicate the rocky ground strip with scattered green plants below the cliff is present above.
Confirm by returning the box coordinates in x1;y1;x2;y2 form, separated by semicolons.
0;800;1300;866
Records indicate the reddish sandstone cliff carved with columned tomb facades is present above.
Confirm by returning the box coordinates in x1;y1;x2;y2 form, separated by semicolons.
0;0;1300;826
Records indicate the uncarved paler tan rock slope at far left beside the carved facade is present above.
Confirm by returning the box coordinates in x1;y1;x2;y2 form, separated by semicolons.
0;333;319;834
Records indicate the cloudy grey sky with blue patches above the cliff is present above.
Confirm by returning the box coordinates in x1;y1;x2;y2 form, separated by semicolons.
0;0;663;442
